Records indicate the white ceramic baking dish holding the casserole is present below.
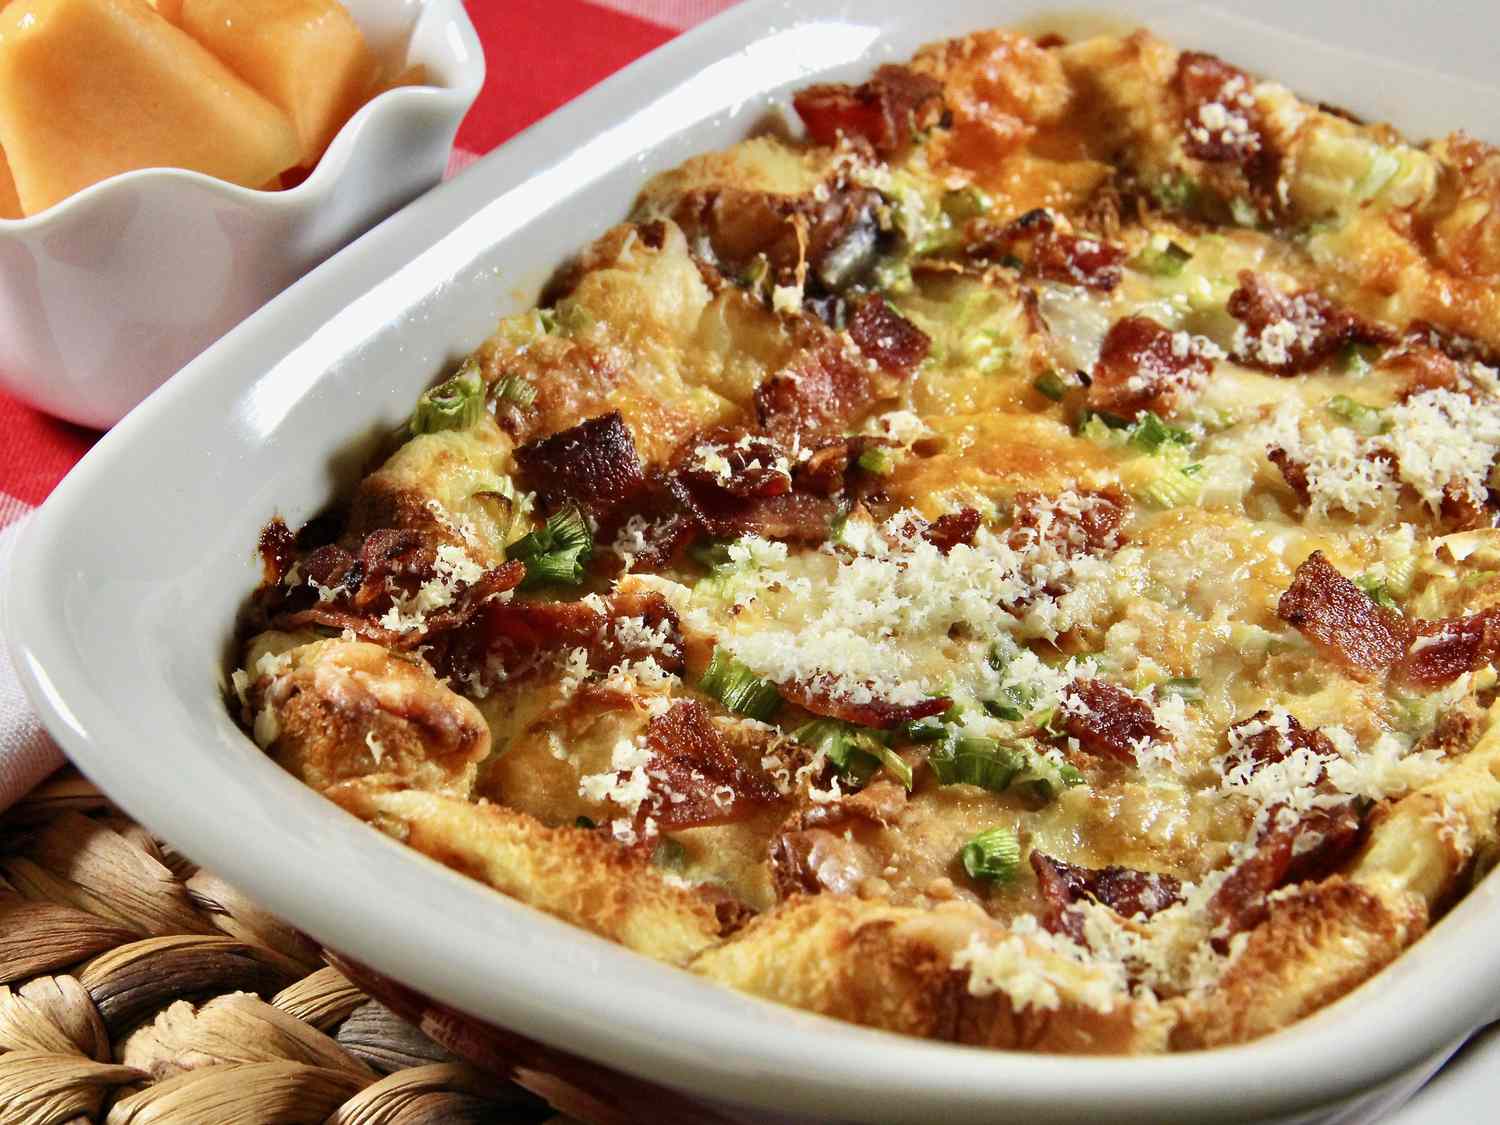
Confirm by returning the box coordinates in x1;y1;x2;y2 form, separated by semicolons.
8;0;1500;1125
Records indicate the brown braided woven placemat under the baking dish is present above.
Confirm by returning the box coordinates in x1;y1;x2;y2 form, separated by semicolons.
0;770;569;1125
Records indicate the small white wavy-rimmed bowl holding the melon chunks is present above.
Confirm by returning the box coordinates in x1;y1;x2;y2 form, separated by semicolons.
0;0;485;428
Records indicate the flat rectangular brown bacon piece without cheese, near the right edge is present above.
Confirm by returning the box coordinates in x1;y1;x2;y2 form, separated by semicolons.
1277;551;1410;680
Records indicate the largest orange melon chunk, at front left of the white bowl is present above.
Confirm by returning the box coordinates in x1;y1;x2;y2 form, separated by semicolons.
0;0;299;215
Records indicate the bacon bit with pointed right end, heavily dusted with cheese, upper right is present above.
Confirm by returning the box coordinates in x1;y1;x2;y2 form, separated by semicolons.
1227;270;1395;375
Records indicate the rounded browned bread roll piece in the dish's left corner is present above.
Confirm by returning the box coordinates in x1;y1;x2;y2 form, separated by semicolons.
246;641;489;797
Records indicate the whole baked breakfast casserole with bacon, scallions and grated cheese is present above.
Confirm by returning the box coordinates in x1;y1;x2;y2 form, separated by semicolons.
230;30;1500;1053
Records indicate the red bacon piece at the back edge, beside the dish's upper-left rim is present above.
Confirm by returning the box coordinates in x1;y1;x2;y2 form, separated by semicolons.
792;63;944;158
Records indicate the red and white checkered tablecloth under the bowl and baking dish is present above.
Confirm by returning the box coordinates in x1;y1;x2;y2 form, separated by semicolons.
0;0;735;809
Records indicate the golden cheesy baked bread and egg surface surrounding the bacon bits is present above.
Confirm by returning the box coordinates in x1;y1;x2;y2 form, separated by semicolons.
234;32;1500;1053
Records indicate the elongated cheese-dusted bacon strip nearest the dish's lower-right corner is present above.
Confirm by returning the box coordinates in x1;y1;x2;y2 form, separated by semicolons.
1208;801;1362;953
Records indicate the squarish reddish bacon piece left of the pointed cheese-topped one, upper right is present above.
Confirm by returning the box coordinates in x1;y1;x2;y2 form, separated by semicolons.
1086;317;1214;420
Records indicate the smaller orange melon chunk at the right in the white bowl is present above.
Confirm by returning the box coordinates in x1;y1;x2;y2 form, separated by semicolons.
182;0;375;165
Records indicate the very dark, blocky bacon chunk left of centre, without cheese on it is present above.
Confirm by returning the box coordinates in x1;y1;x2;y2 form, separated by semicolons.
516;410;645;516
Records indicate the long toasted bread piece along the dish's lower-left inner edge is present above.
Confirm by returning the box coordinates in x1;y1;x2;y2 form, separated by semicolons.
329;782;741;965
